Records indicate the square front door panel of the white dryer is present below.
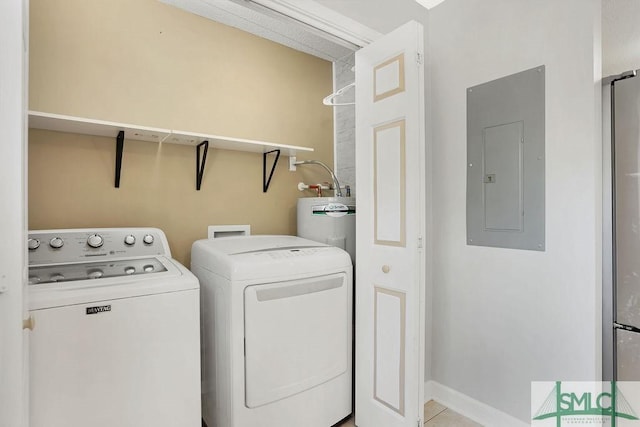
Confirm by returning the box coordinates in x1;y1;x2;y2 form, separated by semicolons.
244;274;351;408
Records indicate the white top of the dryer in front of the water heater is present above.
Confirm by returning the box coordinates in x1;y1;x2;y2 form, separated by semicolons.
191;235;351;281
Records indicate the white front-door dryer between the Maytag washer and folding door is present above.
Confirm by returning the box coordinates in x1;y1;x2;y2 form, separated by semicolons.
191;236;352;427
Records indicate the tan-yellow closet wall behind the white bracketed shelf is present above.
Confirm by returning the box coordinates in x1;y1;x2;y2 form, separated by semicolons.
29;0;333;266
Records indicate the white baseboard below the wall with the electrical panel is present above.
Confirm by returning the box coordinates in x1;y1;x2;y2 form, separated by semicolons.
424;381;529;427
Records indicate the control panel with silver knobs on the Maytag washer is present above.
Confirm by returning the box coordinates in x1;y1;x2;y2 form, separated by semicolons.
27;228;171;265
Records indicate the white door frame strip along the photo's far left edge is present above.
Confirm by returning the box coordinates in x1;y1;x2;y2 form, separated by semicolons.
0;1;26;427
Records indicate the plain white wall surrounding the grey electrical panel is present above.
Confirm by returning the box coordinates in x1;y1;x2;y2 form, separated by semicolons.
429;0;602;422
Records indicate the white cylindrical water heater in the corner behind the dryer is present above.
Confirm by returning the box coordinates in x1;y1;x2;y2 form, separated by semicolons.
298;197;356;264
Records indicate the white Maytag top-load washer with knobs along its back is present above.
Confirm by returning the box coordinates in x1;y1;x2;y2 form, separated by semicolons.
28;228;201;427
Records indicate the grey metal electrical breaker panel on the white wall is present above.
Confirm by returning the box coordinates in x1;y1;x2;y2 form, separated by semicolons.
467;66;545;251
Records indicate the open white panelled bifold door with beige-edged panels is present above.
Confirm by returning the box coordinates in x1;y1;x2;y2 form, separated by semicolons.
356;21;425;427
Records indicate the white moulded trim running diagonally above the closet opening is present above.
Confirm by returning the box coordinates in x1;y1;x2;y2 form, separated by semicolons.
249;0;382;47
